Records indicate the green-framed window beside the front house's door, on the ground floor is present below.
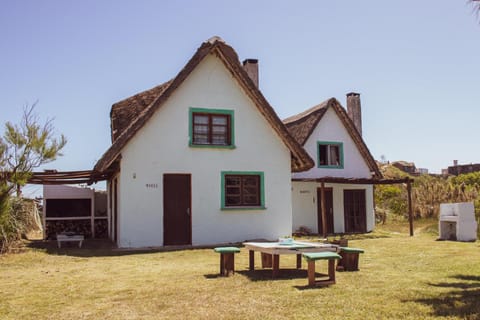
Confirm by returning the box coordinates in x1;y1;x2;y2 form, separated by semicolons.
222;172;265;209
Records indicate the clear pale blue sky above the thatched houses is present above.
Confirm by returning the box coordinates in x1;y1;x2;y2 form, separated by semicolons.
0;0;480;198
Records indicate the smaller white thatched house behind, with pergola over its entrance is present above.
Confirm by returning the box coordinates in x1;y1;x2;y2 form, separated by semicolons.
284;93;382;234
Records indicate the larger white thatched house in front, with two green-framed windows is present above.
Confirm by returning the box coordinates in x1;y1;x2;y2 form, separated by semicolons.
94;37;314;247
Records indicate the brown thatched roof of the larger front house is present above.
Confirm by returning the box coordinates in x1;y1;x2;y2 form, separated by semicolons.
94;37;314;173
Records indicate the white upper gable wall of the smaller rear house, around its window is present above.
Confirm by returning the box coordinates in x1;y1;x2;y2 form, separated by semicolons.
294;108;371;178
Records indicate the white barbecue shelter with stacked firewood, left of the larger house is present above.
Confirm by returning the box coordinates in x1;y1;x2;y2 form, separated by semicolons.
43;185;109;240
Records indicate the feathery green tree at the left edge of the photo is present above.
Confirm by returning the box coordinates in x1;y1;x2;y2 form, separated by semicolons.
0;104;67;253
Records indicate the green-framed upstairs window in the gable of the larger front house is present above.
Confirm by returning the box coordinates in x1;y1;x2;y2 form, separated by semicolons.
190;108;234;148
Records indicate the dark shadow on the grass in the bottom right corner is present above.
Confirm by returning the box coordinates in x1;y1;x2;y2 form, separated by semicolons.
406;275;480;320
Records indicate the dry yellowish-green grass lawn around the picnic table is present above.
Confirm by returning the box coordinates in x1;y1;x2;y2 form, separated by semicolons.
0;221;480;319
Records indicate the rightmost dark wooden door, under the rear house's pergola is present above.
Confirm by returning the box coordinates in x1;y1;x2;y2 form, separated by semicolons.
343;190;367;233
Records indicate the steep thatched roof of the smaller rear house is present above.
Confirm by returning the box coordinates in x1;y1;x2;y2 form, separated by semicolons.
283;98;382;178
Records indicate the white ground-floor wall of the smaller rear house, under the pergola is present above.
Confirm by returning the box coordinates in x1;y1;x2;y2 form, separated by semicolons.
292;181;375;233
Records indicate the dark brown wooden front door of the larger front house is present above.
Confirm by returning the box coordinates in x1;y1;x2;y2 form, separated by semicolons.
163;174;192;245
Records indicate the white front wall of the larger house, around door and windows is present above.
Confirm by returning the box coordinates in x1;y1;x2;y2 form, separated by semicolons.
113;56;292;247
